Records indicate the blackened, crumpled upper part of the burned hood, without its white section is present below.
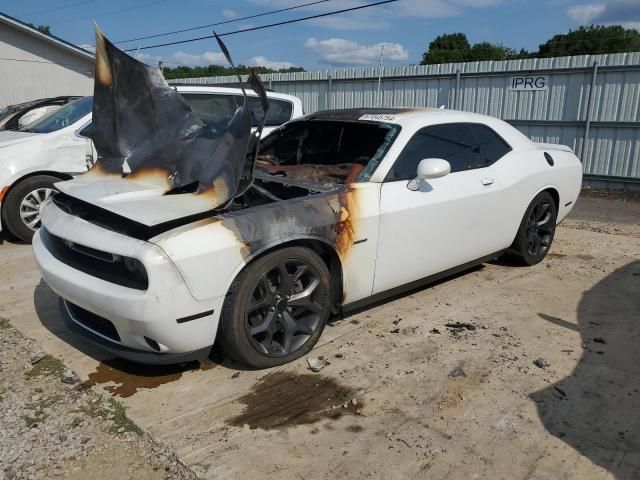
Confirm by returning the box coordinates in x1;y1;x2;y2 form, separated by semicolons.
88;27;268;209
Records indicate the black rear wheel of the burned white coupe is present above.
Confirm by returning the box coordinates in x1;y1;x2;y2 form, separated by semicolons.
508;191;558;266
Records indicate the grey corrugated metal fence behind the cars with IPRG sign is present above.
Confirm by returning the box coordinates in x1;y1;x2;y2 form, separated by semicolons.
172;52;640;181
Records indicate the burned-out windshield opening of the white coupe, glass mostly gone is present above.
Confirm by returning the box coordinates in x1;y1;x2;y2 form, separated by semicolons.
257;120;400;183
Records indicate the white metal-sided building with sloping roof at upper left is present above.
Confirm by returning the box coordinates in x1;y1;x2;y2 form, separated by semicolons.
0;13;95;108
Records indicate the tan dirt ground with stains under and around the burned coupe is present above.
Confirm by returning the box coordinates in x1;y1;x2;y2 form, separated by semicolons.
0;194;640;480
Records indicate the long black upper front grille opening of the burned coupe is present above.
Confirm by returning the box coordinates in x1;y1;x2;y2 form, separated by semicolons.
41;227;149;290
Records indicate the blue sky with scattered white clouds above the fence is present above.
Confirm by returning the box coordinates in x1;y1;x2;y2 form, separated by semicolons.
0;0;640;70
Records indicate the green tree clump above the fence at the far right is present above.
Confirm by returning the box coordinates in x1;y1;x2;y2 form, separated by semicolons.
538;25;640;57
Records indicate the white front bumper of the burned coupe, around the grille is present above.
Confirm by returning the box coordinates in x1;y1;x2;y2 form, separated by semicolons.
33;202;224;363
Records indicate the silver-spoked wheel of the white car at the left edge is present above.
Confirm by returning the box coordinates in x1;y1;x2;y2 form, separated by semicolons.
2;175;60;243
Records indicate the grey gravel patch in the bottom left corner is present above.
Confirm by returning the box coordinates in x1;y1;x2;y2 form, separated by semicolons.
0;319;197;480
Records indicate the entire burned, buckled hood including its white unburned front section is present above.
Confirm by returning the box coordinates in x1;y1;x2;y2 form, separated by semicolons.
57;27;268;225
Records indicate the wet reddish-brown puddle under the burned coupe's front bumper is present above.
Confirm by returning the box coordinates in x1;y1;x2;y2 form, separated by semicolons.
84;358;216;397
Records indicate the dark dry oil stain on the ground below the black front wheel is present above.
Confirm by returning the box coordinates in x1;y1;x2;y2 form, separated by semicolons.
227;372;362;430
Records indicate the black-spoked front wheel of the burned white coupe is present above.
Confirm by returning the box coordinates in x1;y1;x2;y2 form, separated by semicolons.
219;247;331;368
